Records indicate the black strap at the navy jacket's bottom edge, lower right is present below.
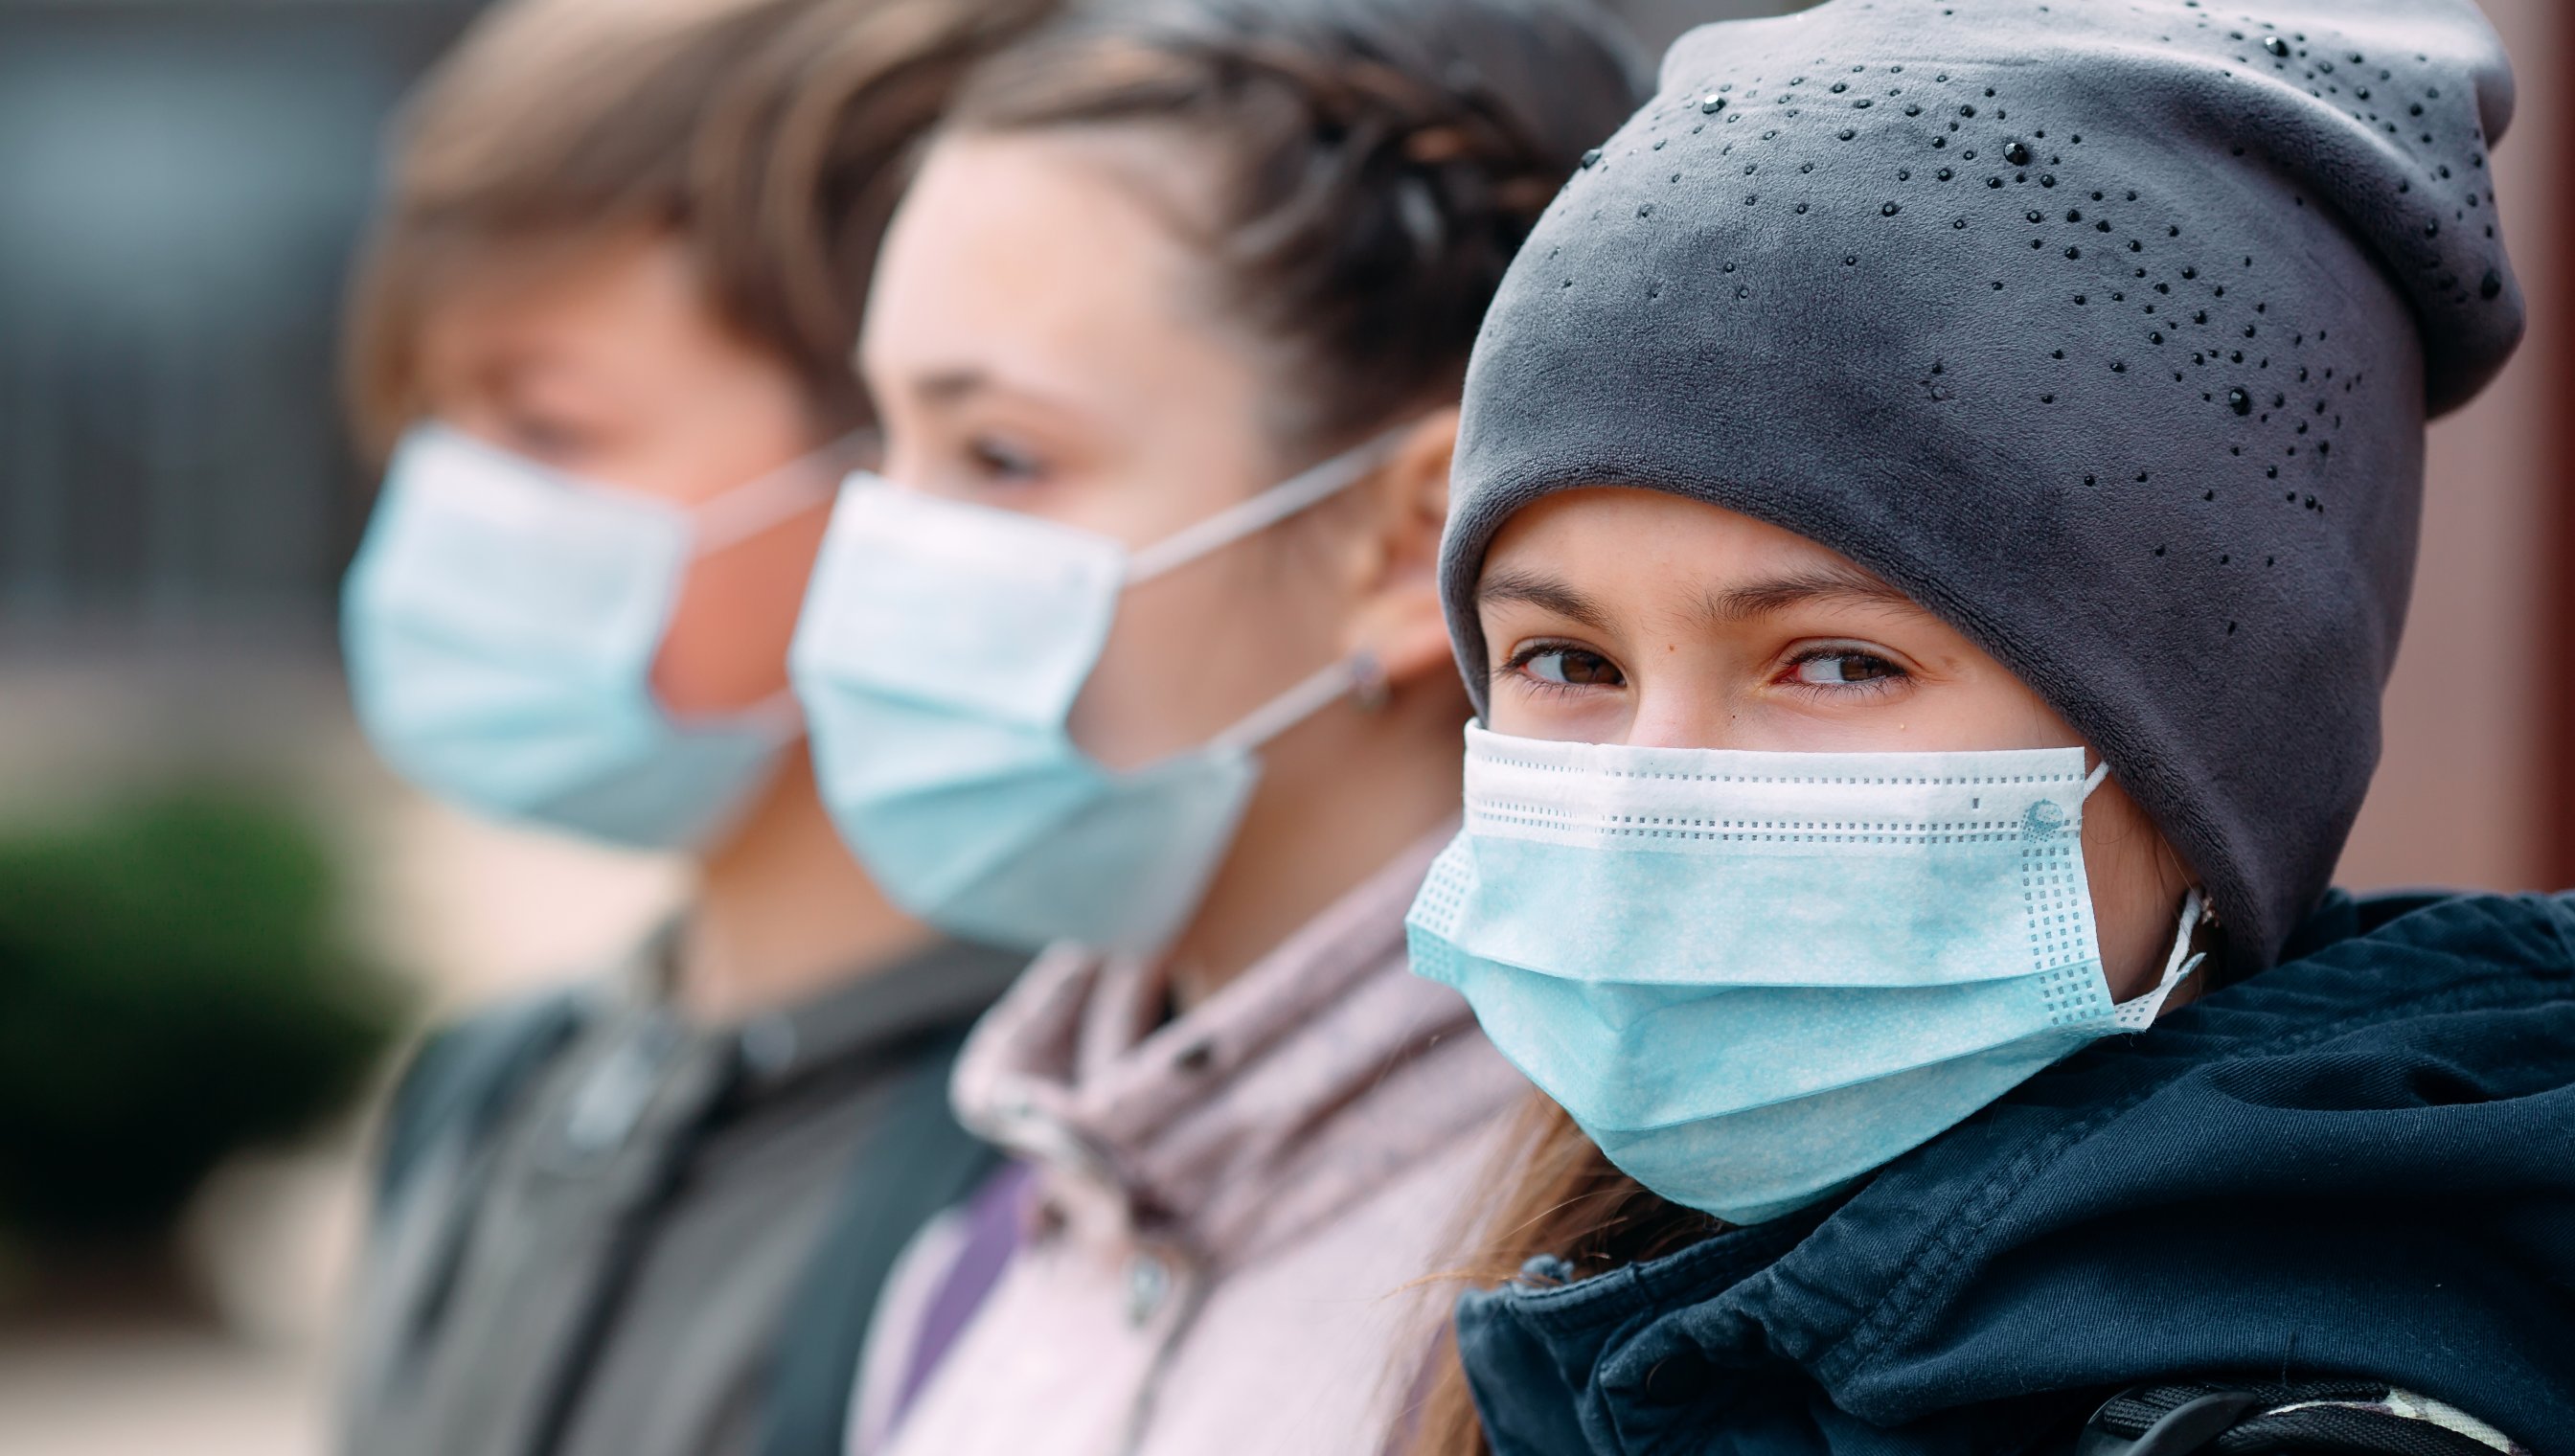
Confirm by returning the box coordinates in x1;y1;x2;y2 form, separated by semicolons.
2073;1381;2521;1456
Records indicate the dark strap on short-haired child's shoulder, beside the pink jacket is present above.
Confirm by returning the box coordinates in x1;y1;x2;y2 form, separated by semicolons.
757;1034;1002;1456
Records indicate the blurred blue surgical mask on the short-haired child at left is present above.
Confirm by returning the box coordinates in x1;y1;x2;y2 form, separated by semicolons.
340;425;837;851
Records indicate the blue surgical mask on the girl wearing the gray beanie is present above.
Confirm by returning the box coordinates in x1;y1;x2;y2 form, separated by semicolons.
1408;727;2201;1224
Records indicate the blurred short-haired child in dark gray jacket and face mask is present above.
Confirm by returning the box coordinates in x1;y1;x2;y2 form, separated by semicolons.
343;0;1043;1456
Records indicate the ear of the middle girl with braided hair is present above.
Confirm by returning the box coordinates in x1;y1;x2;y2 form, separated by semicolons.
1347;407;1457;686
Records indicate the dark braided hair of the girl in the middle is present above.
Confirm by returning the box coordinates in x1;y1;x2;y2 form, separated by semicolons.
947;0;1646;445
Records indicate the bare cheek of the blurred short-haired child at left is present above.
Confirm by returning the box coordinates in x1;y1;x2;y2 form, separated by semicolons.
651;511;830;717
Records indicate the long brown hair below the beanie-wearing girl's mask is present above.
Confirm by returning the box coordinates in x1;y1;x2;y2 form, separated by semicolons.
1401;1093;1725;1456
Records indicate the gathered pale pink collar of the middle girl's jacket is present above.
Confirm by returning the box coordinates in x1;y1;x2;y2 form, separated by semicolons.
955;830;1527;1261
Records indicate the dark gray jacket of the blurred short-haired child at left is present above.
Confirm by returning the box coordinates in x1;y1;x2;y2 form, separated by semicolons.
343;944;1022;1456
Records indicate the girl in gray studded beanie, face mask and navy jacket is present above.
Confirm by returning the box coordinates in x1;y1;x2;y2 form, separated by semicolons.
1411;0;2575;1456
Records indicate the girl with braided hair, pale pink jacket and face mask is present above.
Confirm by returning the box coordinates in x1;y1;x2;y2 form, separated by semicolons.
793;0;1640;1456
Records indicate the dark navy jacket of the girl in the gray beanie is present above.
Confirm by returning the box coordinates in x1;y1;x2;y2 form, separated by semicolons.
1457;897;2575;1456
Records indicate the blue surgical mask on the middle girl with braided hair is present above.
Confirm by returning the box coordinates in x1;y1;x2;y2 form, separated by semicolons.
790;436;1393;956
